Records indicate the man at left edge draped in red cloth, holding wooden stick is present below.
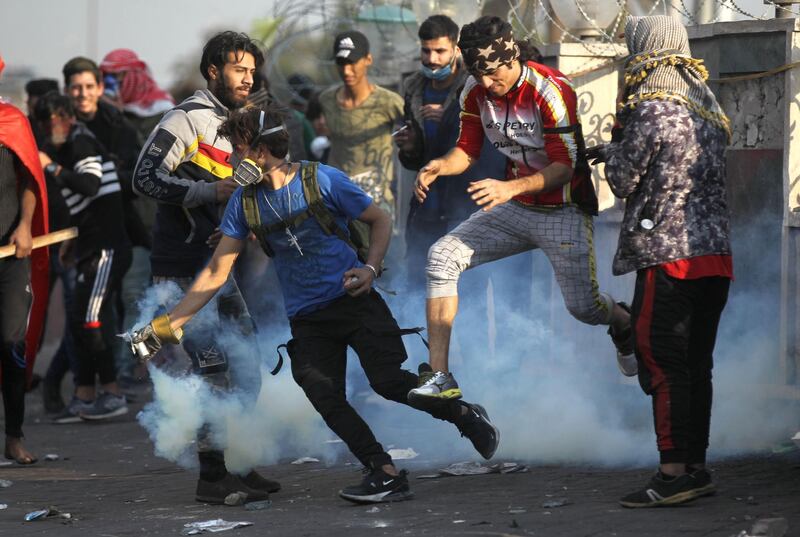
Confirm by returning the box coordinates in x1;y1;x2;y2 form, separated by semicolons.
0;57;48;464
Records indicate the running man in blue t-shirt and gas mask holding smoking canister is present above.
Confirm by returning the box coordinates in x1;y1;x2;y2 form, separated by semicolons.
128;105;498;502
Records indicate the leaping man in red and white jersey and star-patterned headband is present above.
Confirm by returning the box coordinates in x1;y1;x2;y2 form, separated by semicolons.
408;16;636;402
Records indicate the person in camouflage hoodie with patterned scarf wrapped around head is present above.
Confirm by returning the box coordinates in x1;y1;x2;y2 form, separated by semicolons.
590;16;733;507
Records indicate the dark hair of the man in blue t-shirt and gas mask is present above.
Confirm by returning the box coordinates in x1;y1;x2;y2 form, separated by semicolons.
217;105;289;158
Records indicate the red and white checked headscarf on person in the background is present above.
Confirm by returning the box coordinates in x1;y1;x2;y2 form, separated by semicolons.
100;48;175;109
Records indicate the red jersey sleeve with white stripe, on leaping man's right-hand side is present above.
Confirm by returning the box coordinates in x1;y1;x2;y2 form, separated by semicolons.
531;65;578;168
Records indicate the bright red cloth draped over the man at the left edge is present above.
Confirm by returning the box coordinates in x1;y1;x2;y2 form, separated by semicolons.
0;101;50;381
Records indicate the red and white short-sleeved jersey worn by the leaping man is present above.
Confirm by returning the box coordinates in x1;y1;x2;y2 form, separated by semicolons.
457;62;597;214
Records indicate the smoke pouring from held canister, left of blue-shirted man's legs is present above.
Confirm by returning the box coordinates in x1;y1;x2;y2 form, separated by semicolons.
137;283;338;473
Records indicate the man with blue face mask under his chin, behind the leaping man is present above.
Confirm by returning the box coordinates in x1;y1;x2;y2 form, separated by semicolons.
395;15;505;298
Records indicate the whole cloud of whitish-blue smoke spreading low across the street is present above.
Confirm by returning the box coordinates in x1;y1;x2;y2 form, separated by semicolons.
130;237;797;471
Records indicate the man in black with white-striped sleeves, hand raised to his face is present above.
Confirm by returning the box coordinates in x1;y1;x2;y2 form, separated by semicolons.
35;93;131;423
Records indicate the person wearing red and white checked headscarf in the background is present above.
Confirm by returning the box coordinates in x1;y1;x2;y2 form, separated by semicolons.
100;48;175;138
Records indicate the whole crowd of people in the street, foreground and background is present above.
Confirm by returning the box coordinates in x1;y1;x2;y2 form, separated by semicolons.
0;11;733;507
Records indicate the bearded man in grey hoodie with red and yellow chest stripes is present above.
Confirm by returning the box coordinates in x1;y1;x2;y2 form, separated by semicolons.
133;31;280;503
